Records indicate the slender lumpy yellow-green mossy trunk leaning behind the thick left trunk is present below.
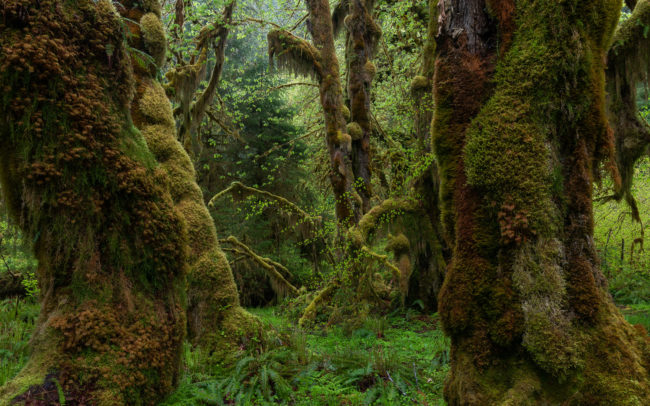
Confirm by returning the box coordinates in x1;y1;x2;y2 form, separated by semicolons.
116;1;261;361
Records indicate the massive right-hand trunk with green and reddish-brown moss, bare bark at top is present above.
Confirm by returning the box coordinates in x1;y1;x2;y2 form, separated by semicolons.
432;0;650;405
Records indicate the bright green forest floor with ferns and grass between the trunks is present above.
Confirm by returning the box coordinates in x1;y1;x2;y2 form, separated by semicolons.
0;299;650;406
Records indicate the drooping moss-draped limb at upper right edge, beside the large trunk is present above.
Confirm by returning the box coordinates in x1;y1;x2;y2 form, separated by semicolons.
607;0;650;221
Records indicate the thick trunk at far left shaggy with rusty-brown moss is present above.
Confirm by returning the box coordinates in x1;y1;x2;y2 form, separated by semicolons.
0;0;187;405
